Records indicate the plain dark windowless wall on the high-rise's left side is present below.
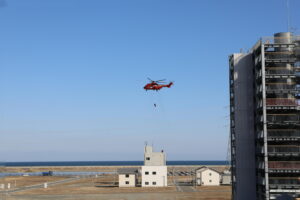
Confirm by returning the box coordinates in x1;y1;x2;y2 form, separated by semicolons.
232;53;256;200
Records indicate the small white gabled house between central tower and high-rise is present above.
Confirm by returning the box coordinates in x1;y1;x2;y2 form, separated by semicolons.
196;167;221;186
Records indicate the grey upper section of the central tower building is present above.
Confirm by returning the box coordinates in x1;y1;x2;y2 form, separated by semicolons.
144;146;166;166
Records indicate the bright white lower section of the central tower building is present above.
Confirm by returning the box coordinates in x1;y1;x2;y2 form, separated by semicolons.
142;166;168;187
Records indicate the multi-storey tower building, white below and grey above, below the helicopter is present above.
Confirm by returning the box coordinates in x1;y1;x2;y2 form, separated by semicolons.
142;145;168;187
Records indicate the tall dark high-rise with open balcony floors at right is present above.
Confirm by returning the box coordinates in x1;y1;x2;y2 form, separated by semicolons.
229;32;300;200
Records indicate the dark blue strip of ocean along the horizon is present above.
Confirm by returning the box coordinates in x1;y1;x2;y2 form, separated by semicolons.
2;160;230;167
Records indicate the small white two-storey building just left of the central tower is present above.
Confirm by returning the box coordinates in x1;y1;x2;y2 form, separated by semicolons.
118;168;138;187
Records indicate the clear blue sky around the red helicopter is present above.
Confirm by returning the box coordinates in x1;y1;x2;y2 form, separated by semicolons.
0;0;300;161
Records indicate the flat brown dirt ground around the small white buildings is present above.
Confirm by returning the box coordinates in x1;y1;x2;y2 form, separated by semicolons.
0;167;231;200
